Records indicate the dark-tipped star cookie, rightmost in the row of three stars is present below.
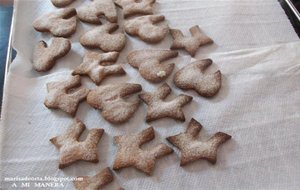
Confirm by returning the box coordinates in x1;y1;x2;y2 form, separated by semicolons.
167;119;231;166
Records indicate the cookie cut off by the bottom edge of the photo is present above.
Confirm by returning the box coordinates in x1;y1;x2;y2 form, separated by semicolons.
74;167;114;190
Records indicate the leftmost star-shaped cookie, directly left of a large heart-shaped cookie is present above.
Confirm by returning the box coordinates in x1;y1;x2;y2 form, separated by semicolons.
44;76;89;116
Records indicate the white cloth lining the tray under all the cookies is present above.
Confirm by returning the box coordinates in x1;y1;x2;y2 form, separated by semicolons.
0;0;300;190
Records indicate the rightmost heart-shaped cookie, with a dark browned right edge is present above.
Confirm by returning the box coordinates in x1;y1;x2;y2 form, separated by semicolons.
174;59;222;97
